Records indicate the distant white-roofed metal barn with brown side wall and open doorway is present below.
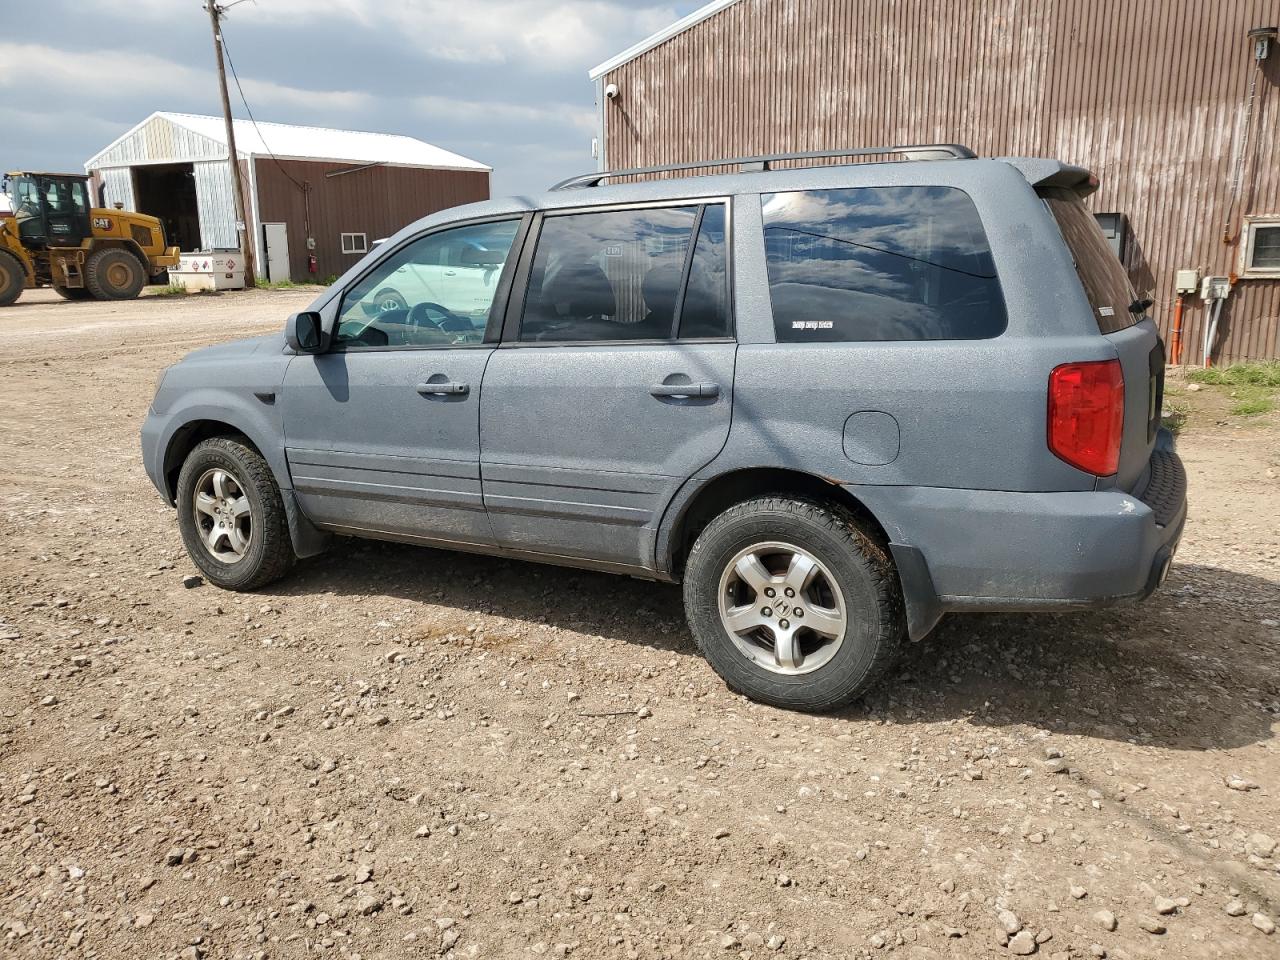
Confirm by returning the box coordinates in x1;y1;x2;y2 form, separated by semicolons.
84;113;492;280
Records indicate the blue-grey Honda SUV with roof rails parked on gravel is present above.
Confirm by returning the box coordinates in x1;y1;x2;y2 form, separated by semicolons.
142;145;1187;710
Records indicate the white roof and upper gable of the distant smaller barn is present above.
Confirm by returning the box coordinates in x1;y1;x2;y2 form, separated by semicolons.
84;111;493;172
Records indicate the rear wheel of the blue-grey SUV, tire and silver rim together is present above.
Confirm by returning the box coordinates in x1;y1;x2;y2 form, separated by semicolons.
685;497;905;710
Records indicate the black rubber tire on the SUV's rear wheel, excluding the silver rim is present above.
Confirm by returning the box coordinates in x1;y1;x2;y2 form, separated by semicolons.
684;495;906;712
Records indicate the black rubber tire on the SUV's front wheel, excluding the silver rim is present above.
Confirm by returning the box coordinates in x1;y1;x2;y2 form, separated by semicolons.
178;436;297;590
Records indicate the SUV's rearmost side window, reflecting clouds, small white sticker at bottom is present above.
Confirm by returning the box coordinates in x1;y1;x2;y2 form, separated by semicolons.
762;187;1007;343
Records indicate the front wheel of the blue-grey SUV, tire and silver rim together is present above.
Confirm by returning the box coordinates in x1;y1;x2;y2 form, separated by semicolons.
177;436;296;590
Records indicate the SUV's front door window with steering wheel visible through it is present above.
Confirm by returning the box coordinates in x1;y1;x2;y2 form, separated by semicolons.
334;220;520;348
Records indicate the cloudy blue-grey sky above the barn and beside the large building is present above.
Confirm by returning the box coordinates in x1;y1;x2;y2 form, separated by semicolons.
0;0;701;195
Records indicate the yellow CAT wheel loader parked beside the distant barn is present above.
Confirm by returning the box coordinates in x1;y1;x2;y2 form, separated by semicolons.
0;173;178;307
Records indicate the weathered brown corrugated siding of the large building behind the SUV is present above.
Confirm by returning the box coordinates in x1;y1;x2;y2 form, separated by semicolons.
604;0;1280;362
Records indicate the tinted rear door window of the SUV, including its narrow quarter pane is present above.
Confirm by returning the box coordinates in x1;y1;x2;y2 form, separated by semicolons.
520;204;728;343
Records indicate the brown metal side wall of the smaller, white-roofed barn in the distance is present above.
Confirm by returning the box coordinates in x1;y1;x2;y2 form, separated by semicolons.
253;157;489;280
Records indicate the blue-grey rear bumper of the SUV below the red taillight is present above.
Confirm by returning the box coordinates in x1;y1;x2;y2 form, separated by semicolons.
849;447;1187;637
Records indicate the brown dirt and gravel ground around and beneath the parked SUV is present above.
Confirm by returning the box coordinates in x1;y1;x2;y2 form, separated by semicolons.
0;292;1280;960
